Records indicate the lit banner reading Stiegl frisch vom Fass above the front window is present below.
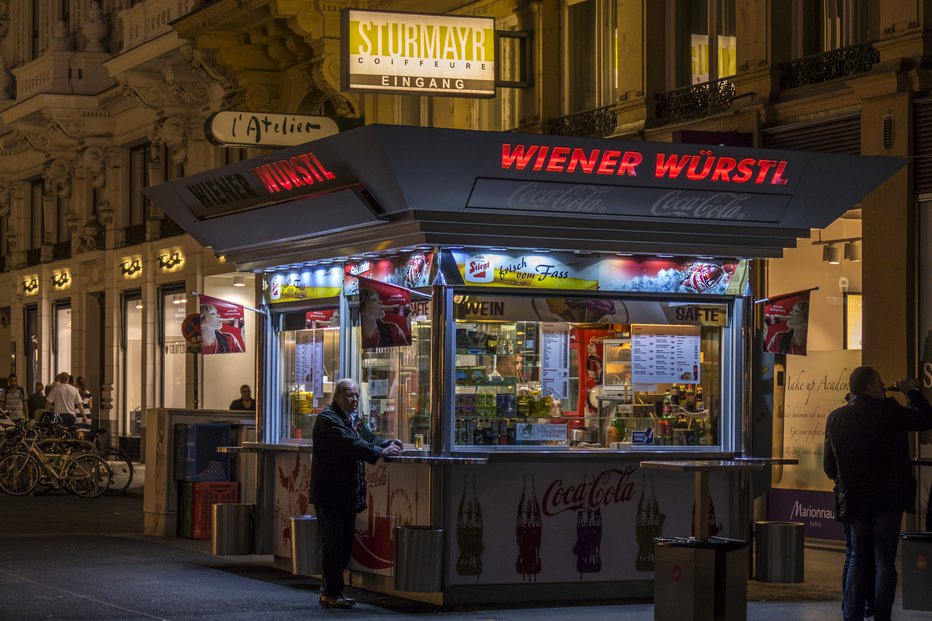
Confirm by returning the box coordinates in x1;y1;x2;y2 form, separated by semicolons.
452;250;747;295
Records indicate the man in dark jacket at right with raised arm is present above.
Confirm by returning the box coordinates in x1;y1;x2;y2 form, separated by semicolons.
822;366;932;621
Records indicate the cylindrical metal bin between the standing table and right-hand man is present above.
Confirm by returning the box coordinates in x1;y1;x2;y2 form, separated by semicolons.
754;522;806;583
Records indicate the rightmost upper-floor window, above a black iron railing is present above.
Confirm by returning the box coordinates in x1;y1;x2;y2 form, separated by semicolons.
792;0;880;58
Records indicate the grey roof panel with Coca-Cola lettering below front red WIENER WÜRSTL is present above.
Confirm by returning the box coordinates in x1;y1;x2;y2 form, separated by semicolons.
467;179;789;223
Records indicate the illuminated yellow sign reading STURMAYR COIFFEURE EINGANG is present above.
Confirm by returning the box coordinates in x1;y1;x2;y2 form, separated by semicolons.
340;9;495;97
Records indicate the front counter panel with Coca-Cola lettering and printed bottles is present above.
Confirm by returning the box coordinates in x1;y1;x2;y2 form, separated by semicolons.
446;460;737;585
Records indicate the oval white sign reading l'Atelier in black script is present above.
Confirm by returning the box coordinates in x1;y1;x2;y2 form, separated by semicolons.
204;110;340;147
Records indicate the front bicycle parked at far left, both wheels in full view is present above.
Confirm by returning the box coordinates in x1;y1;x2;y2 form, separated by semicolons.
0;432;111;498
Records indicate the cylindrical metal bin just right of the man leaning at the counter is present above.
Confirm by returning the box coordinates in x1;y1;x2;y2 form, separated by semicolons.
395;526;443;593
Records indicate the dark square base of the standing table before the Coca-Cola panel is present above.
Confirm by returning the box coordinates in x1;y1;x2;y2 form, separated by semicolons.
654;537;748;621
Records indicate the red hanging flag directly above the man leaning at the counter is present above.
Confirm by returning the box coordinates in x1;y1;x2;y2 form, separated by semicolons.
359;277;411;349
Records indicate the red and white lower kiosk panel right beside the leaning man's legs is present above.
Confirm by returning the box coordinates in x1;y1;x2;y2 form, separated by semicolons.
350;461;430;575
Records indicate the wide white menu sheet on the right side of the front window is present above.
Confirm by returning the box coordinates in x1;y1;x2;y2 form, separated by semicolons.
631;324;701;384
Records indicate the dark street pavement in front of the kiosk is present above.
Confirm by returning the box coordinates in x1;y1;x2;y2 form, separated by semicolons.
0;470;932;621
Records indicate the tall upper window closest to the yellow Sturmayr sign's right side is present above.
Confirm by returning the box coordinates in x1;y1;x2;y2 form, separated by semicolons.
563;0;618;113
